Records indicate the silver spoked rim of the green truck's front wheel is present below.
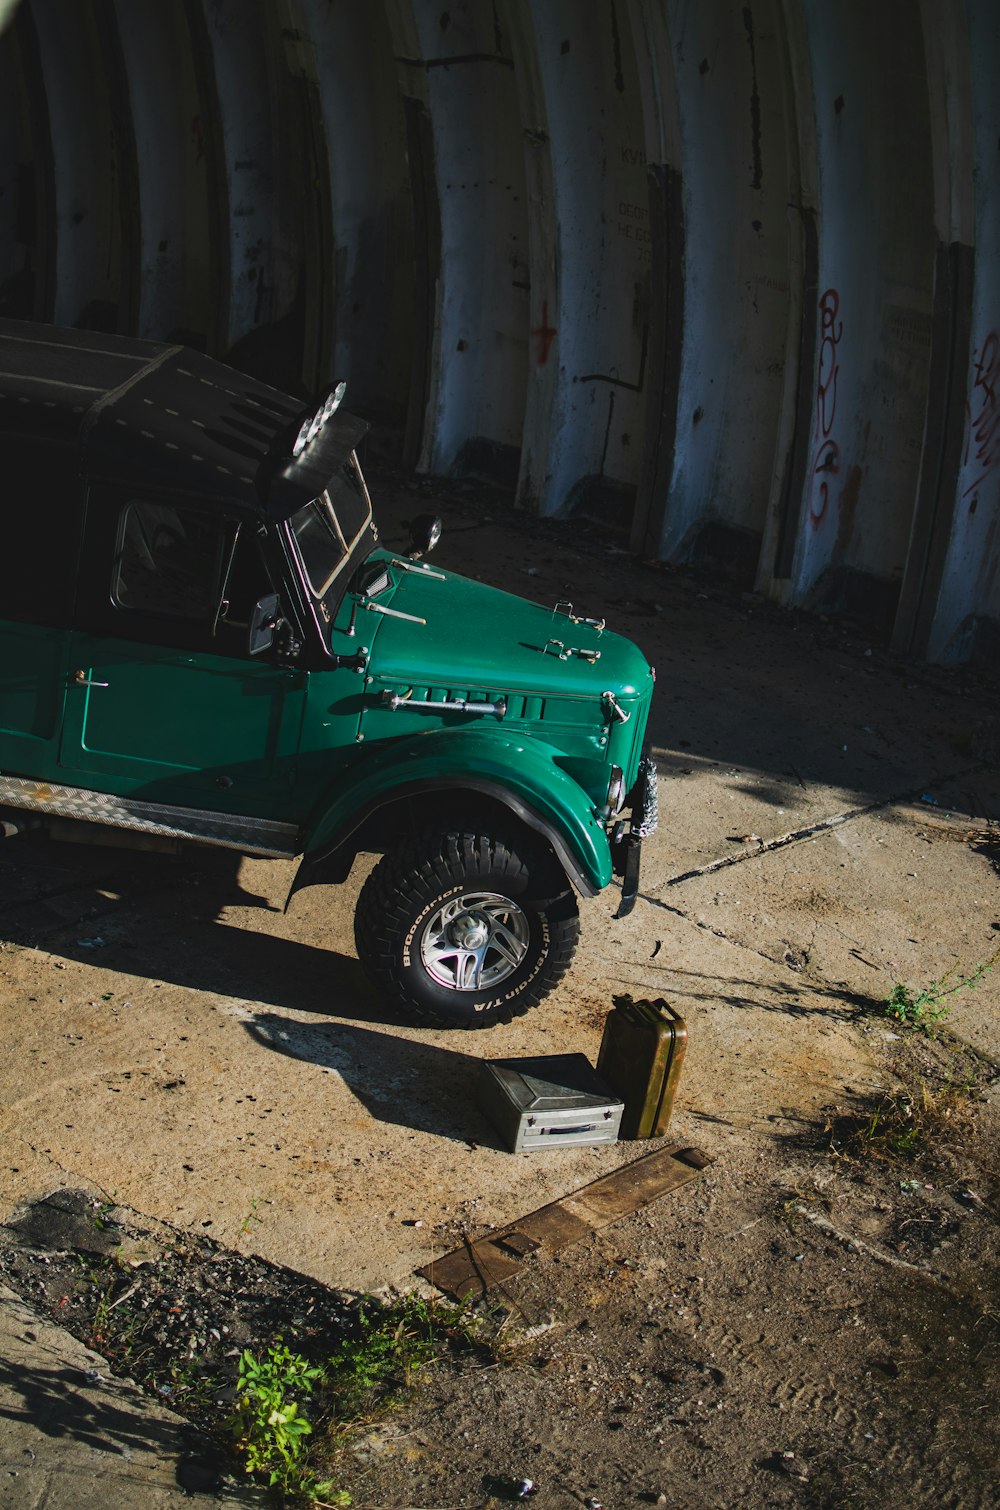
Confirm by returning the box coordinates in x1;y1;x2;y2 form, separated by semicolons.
420;891;530;991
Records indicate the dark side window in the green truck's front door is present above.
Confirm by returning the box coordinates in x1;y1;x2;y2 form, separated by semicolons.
112;498;225;624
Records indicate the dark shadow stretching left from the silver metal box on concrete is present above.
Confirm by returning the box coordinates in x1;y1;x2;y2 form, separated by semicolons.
245;1012;502;1148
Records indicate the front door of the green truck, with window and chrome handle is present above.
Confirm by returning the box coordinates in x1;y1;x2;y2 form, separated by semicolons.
59;494;308;821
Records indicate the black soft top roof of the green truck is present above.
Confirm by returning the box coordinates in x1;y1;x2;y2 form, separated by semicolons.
0;320;367;518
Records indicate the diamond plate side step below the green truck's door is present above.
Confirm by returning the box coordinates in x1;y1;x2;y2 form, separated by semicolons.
0;772;299;859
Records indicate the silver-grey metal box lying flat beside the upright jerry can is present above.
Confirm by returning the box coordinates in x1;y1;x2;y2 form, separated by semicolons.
479;1054;624;1154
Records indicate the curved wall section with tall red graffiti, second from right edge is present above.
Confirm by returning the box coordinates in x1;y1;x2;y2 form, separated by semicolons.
792;0;935;628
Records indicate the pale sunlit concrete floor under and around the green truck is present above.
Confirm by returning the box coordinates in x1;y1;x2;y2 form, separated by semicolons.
0;480;1000;1290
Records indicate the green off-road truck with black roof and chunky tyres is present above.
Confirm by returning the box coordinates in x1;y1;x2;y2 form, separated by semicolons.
0;320;656;1025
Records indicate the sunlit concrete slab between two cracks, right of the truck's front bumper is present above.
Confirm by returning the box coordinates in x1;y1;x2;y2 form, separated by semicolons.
665;803;1000;1055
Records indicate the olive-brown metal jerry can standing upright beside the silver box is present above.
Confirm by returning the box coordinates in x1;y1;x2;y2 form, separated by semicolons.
597;997;687;1139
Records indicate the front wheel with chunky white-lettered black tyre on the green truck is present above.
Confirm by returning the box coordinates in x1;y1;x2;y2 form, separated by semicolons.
355;829;580;1028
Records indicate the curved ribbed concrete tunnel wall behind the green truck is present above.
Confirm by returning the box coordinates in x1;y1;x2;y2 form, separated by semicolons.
0;0;1000;664
